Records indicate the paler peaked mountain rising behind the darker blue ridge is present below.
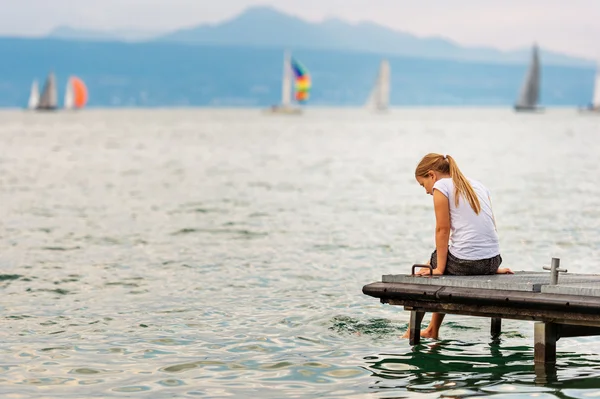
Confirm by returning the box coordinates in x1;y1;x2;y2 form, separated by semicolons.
156;7;594;66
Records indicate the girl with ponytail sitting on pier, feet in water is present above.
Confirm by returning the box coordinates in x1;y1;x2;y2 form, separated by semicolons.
404;153;513;339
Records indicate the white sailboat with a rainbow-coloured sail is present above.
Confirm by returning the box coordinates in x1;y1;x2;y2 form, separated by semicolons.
266;52;312;115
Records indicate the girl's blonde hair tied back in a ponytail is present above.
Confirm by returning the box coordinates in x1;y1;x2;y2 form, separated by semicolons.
415;153;481;214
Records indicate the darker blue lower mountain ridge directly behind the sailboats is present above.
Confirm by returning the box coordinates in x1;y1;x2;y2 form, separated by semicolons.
0;38;595;108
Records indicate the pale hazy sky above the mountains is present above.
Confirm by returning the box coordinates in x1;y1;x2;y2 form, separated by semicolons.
0;0;600;61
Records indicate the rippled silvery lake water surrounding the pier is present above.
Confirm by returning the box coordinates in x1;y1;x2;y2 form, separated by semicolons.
0;109;600;399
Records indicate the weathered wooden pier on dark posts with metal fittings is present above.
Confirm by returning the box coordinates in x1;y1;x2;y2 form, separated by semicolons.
363;258;600;365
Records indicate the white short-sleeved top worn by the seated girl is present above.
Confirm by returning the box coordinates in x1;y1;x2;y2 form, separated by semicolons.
433;178;500;260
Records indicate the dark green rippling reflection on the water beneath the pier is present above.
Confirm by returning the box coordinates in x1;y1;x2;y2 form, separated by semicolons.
364;340;600;397
